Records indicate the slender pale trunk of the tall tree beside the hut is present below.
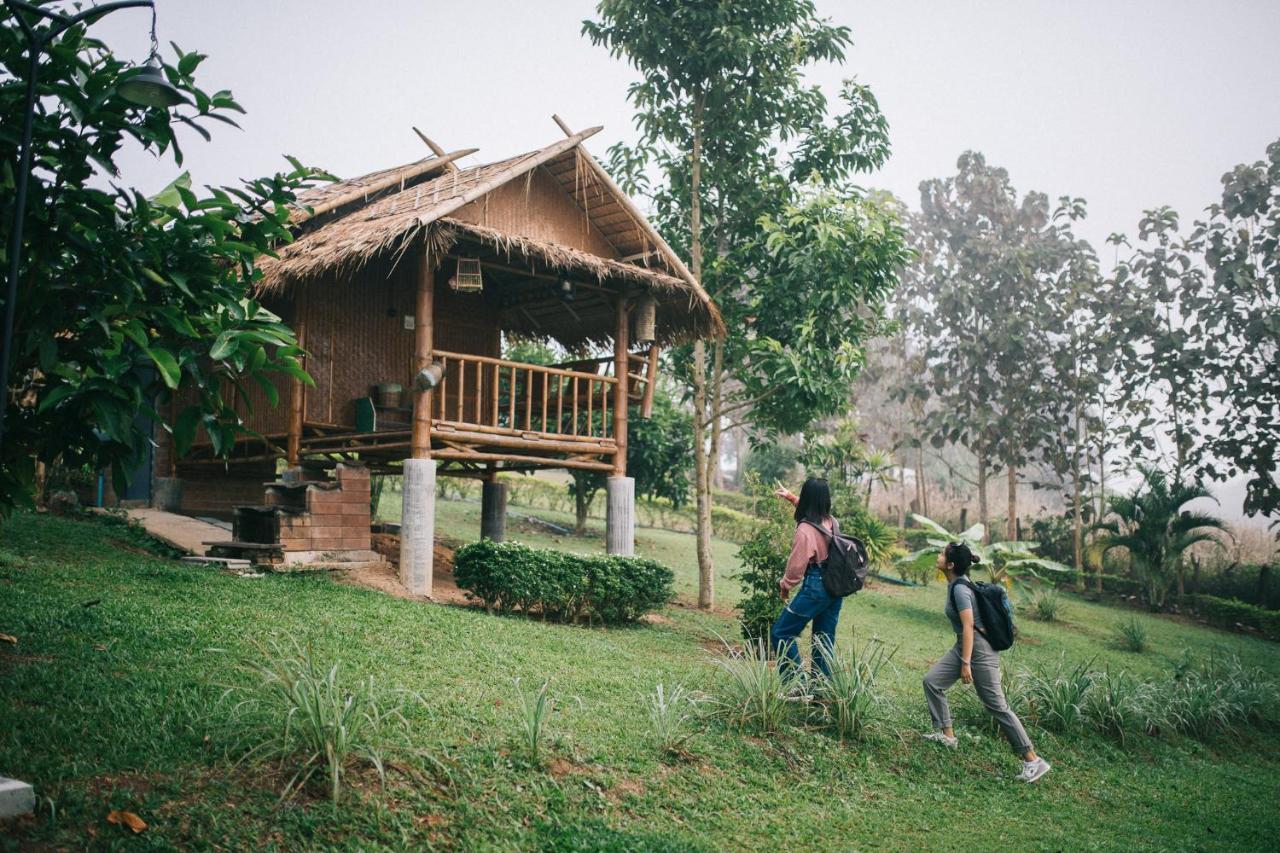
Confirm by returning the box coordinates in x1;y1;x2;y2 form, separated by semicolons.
689;92;716;610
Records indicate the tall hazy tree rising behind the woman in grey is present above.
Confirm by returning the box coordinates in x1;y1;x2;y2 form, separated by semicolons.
909;151;1061;539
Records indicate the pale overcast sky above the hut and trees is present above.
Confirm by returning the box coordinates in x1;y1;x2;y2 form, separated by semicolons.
95;0;1280;257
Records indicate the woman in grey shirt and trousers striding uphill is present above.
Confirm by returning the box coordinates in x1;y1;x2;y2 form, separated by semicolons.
924;542;1050;783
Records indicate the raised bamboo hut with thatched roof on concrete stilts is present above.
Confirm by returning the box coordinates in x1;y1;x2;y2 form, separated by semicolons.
157;119;722;592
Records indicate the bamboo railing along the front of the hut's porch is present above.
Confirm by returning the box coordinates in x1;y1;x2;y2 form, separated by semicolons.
431;350;617;444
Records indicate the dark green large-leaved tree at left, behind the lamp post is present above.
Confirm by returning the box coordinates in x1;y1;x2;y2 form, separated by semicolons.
0;17;320;515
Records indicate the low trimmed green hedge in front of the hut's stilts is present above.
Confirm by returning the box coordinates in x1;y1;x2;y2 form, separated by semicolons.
453;539;675;625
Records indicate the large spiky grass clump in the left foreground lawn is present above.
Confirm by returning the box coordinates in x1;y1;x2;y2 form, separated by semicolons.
224;643;411;802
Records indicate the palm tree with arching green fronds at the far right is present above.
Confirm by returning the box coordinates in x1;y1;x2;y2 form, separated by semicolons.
1093;466;1229;610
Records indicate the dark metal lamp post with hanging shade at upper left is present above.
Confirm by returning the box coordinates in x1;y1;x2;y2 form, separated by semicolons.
0;0;186;458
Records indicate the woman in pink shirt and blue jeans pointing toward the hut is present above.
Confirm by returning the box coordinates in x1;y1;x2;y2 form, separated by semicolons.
769;476;844;676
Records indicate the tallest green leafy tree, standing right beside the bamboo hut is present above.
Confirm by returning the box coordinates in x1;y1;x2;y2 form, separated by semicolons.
584;0;901;607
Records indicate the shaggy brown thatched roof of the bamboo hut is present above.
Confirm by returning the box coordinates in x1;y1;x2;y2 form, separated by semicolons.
259;128;723;346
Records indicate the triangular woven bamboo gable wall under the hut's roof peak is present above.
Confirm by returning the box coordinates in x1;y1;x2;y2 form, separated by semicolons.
451;169;621;260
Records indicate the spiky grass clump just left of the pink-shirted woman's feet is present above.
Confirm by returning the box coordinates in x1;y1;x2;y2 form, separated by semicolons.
710;638;790;733
